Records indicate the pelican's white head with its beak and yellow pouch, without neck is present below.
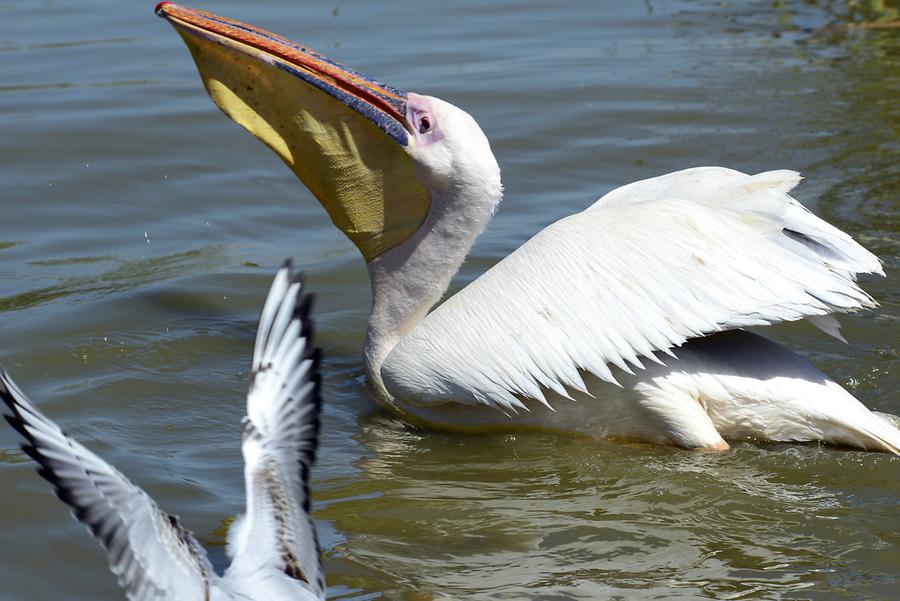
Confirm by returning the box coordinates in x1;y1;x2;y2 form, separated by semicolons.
156;2;500;263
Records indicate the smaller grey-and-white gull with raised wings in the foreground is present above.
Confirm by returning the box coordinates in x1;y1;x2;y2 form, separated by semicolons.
0;263;325;601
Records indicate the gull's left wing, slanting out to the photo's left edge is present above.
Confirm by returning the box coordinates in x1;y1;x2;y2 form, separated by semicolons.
0;370;215;601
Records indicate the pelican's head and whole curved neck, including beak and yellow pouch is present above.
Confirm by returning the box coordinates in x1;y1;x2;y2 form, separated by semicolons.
156;2;502;409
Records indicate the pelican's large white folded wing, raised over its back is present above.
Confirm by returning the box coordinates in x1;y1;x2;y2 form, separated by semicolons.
382;167;883;412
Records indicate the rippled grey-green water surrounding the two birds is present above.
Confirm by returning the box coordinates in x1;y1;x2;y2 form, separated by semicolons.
0;0;900;601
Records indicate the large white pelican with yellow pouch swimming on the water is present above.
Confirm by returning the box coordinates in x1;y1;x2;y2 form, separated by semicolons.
156;2;900;453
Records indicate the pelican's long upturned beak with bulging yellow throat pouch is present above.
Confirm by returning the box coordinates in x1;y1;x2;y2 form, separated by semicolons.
156;2;430;261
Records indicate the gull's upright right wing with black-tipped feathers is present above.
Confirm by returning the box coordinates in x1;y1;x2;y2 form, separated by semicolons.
229;263;325;598
